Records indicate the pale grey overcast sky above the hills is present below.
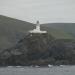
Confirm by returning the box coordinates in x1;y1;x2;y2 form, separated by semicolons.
0;0;75;23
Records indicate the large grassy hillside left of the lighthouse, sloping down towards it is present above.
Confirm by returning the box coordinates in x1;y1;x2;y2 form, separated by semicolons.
0;15;33;48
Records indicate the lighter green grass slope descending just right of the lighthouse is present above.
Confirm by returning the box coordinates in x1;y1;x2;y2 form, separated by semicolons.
42;25;74;39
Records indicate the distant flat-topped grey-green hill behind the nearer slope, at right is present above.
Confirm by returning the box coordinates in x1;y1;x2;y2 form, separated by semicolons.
42;23;75;38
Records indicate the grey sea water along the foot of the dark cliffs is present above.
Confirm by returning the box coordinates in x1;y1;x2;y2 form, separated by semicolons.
0;65;75;75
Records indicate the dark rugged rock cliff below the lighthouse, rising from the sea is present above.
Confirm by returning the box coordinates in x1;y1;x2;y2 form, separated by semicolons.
0;34;75;66
